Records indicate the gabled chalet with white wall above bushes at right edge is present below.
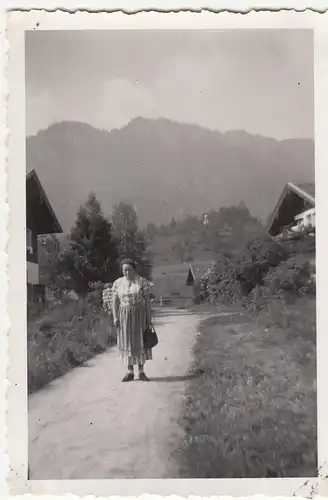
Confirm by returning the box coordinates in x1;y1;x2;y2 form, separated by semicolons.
268;182;315;237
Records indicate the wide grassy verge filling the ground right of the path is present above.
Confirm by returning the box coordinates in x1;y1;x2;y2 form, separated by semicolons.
176;299;317;478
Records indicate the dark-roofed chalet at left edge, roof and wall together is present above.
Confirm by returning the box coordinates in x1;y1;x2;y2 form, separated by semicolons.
26;170;63;302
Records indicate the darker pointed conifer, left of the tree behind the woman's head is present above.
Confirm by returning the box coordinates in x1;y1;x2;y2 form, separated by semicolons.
59;194;118;293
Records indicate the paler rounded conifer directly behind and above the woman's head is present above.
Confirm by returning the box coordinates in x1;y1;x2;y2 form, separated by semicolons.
112;202;152;278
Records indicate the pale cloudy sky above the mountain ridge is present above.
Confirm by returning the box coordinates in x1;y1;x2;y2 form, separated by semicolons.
26;30;314;139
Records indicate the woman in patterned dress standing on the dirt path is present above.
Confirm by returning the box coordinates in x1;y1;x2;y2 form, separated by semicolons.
112;259;152;382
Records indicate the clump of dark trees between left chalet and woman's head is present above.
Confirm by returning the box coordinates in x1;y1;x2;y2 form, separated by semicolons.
39;194;152;294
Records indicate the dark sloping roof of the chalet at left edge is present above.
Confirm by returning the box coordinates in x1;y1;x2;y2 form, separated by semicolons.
26;170;63;234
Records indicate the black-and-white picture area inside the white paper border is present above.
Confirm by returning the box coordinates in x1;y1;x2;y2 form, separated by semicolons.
5;10;328;494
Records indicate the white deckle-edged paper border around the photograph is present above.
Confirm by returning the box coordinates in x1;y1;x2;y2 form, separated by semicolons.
0;10;328;499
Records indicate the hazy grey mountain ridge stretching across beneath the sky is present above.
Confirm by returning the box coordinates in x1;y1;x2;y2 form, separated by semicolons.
26;117;314;230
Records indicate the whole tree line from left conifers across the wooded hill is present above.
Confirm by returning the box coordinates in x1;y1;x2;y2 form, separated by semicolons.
39;199;264;293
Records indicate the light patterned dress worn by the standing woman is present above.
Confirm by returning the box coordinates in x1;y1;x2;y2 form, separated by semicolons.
112;276;152;365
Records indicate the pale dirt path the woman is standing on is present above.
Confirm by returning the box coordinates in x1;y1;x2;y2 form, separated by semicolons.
29;310;199;479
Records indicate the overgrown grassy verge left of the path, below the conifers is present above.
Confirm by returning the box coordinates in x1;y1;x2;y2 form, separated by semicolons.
27;299;116;393
